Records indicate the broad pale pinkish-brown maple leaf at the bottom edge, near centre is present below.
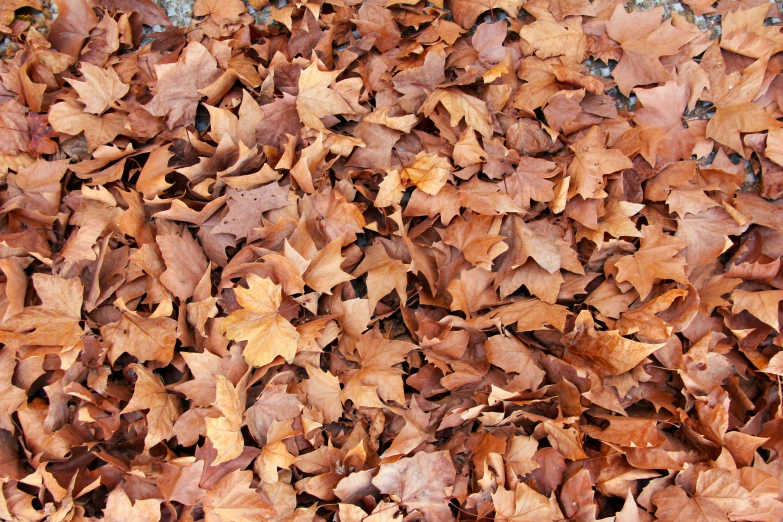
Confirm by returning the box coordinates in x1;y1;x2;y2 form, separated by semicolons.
372;451;456;522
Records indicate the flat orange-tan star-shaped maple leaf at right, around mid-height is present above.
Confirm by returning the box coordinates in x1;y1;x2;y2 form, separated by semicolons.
616;225;688;299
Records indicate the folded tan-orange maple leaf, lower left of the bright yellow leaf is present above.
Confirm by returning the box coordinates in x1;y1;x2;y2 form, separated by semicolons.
122;364;182;449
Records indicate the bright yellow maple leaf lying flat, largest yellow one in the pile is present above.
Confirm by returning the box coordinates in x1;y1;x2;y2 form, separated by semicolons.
220;274;299;367
